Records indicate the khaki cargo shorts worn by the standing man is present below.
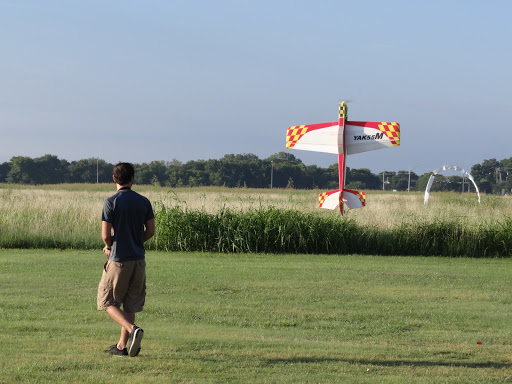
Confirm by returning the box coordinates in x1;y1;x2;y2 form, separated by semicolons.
97;260;146;313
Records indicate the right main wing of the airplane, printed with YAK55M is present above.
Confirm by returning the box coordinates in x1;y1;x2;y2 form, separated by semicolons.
345;121;400;155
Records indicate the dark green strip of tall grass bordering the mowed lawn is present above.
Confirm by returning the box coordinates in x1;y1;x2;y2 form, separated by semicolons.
150;202;512;257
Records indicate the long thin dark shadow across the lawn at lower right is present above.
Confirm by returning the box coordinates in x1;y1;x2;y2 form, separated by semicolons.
266;356;512;369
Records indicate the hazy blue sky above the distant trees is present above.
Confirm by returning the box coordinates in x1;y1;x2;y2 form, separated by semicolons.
0;0;512;174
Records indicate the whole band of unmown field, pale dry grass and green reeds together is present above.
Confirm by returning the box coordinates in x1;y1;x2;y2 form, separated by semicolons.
0;184;512;257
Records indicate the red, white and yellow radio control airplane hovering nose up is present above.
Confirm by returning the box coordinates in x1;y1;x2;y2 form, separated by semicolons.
286;101;400;215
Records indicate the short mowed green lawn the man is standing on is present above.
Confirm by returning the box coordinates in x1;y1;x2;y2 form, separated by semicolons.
0;250;512;383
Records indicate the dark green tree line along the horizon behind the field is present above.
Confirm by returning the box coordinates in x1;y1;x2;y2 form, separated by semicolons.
0;152;512;193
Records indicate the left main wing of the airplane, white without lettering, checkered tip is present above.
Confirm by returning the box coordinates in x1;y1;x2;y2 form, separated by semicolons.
286;121;342;154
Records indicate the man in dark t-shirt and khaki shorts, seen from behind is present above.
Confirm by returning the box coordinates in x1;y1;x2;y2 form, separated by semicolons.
98;163;155;357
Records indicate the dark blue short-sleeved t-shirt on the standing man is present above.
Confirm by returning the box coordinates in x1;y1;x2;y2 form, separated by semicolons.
101;189;155;261
